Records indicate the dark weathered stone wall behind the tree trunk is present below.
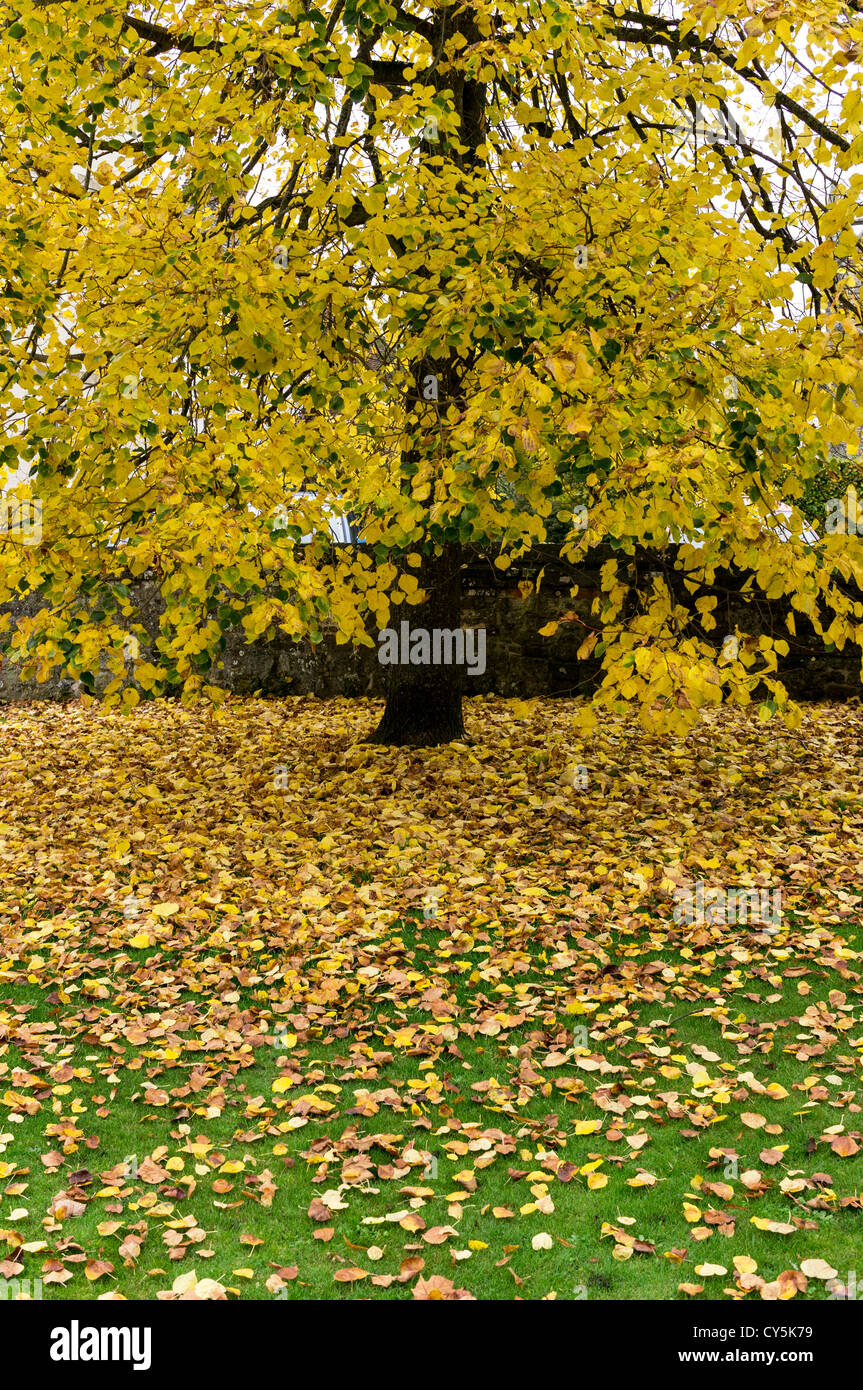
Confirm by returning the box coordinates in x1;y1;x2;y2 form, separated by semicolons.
0;545;863;701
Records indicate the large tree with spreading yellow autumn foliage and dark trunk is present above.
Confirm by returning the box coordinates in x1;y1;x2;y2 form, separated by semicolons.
0;0;863;742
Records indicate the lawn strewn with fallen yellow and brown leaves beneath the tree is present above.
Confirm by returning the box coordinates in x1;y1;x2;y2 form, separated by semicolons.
0;699;863;1301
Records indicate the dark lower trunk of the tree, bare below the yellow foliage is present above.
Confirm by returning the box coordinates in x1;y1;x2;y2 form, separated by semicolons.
370;545;464;748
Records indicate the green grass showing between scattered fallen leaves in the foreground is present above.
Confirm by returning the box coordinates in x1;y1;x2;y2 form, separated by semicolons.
0;922;863;1300
